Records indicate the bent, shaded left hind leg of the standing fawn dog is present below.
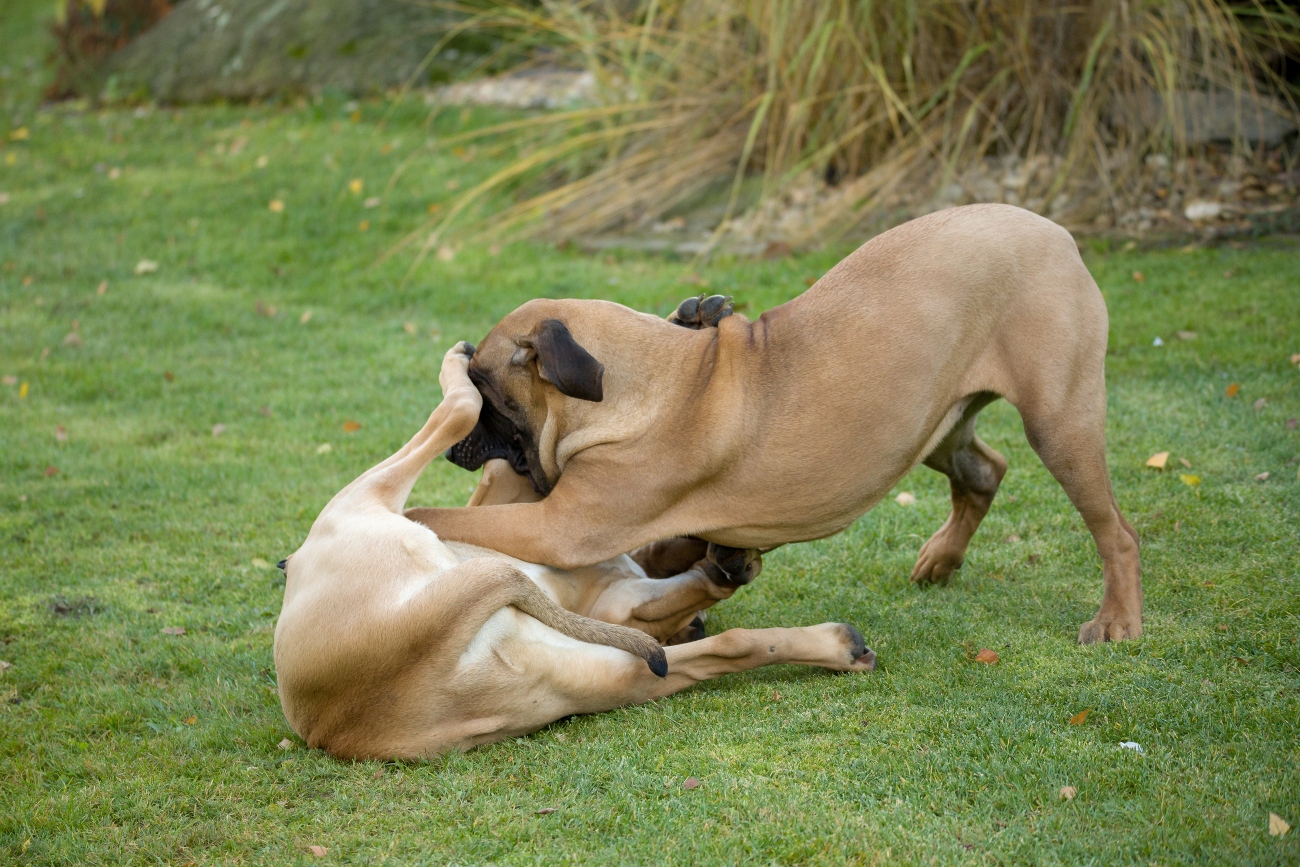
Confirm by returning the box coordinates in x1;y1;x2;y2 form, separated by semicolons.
911;394;1006;584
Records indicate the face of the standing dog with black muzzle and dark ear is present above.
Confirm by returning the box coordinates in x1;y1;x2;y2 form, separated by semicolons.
447;315;605;494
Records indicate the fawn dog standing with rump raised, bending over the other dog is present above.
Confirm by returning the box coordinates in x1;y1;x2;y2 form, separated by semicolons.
407;205;1141;642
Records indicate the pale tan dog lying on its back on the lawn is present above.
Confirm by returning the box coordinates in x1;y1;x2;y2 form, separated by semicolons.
274;343;876;759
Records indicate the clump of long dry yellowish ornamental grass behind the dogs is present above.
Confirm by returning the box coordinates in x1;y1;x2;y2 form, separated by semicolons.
407;0;1300;253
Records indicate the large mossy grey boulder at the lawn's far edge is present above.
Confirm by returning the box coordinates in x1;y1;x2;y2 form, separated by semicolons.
104;0;489;103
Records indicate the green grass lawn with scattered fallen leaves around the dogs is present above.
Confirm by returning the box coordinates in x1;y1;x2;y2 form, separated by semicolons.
0;4;1300;864
